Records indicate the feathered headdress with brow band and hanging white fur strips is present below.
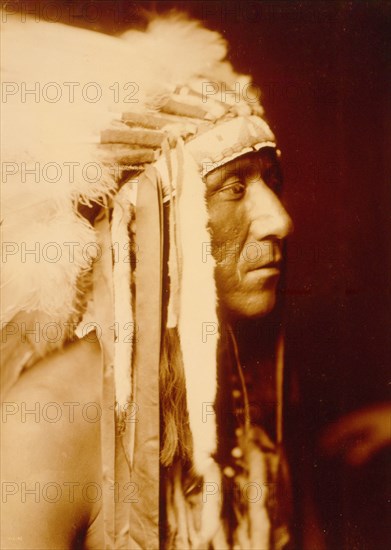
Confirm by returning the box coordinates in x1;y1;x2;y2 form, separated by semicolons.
1;10;275;544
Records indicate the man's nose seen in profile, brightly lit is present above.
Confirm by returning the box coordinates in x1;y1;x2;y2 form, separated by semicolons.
248;181;293;240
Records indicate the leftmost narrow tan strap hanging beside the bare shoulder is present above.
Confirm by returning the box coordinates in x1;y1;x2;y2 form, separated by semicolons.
93;209;137;550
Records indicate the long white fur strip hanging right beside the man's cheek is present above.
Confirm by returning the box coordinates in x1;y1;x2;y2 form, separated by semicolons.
178;151;218;474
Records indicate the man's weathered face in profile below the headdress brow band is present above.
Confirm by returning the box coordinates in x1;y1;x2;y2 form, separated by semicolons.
205;147;292;317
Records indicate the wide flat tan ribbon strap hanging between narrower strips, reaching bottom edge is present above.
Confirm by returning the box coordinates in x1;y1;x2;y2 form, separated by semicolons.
129;166;163;550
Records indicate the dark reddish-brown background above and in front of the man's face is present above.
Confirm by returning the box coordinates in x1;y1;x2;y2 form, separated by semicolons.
5;0;391;550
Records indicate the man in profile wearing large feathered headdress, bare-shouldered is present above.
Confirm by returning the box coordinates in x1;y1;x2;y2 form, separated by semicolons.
2;9;291;550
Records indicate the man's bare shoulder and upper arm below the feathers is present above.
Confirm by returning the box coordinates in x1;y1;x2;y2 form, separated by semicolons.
1;340;101;549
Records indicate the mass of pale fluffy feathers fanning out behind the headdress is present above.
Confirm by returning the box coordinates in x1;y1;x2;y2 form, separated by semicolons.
1;15;231;338
